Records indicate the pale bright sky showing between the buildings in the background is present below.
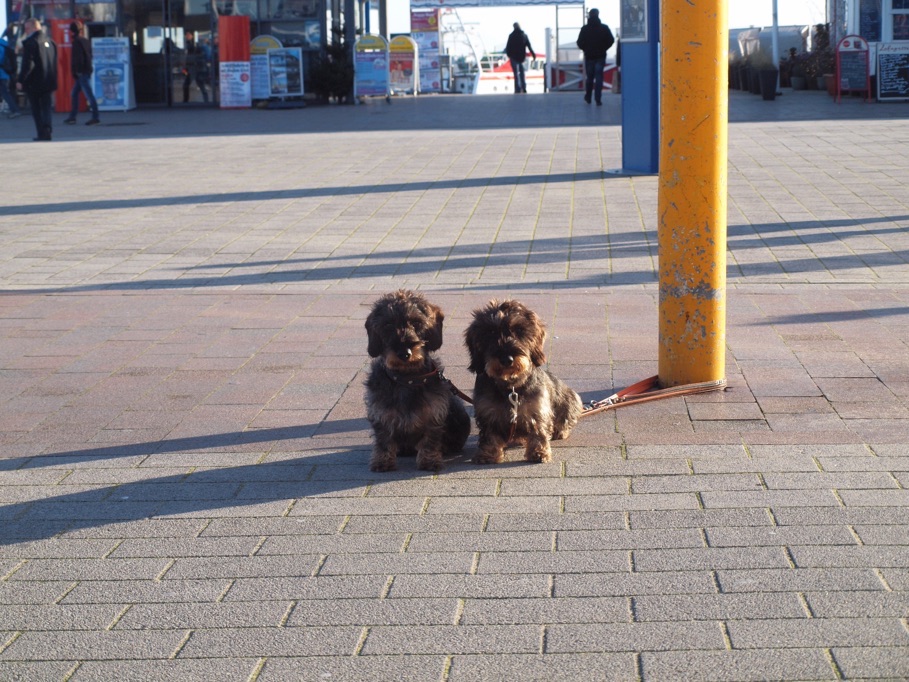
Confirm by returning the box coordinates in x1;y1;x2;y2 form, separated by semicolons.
371;0;826;55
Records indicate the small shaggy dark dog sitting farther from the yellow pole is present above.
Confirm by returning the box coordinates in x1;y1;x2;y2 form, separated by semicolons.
366;289;470;471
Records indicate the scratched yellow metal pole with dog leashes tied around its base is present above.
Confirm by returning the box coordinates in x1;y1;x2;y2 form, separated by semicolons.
657;0;729;387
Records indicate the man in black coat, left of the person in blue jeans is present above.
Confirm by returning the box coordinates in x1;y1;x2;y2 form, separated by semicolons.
16;18;57;141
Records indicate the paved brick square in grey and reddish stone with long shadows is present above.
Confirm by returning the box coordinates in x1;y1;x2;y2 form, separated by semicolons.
0;91;909;682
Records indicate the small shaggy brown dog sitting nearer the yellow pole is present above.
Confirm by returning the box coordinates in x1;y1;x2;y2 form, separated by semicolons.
464;300;583;464
